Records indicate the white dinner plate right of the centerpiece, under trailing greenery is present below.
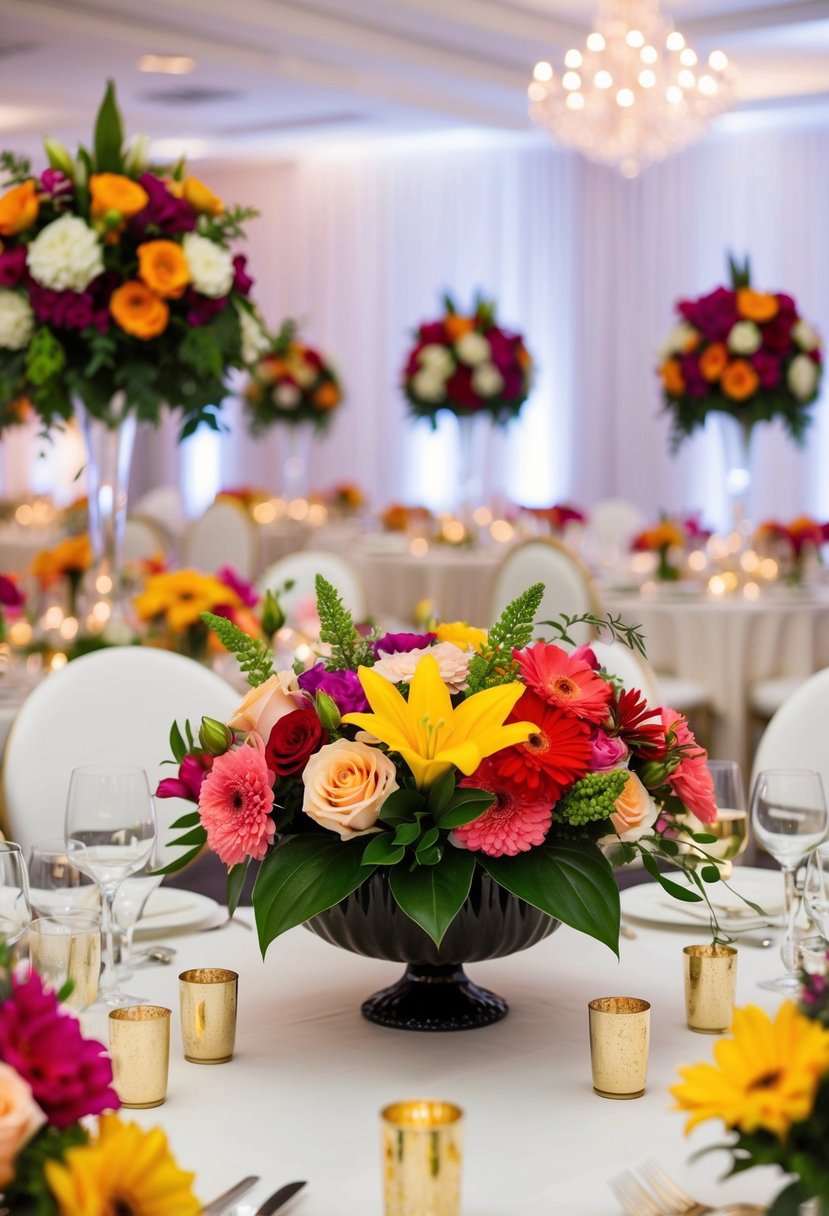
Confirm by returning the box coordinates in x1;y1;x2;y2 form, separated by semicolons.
621;866;783;933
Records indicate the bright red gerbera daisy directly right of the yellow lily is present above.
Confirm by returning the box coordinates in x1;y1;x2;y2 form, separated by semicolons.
490;688;591;806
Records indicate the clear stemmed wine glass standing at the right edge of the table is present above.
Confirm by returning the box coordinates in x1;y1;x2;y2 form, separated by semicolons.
751;769;829;995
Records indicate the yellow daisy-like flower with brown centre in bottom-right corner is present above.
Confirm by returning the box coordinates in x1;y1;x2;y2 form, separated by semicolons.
671;1001;829;1139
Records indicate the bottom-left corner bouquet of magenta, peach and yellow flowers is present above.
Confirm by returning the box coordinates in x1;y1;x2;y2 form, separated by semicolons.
0;947;196;1216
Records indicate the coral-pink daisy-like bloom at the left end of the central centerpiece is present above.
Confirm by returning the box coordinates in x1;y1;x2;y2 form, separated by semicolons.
198;734;276;866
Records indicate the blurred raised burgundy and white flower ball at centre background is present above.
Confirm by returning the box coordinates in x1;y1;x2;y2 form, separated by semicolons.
402;295;532;426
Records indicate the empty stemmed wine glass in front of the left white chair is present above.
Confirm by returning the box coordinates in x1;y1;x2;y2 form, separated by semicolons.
66;765;156;1008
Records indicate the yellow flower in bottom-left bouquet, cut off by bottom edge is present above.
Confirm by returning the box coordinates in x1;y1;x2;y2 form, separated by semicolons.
44;1115;202;1216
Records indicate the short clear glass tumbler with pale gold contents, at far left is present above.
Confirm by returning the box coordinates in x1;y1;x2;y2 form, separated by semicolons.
29;912;101;1012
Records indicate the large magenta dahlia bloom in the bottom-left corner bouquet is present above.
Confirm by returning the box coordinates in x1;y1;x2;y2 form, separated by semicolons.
0;972;120;1127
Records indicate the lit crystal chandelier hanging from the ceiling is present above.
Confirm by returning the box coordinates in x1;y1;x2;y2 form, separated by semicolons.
528;0;733;178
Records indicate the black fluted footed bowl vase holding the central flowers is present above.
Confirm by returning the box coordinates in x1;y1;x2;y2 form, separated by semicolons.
305;872;559;1030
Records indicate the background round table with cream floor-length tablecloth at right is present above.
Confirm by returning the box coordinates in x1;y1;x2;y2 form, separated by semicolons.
603;585;829;765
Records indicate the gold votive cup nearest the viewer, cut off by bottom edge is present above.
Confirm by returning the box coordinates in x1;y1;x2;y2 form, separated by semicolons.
380;1098;463;1216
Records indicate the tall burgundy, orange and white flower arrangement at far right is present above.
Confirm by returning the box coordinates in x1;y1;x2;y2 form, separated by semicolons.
659;259;823;447
